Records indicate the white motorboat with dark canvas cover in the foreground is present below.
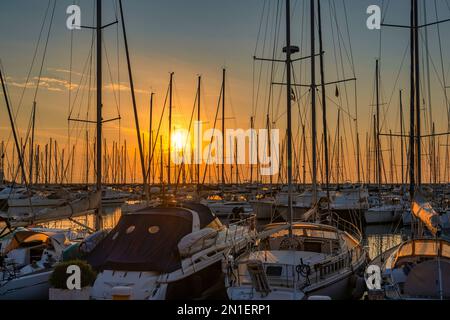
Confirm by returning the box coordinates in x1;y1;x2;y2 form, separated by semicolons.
87;203;254;300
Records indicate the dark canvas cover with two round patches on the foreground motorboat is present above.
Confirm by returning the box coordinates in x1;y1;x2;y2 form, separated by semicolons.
87;207;214;273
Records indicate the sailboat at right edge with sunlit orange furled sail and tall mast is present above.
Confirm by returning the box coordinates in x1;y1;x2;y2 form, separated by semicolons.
368;0;450;300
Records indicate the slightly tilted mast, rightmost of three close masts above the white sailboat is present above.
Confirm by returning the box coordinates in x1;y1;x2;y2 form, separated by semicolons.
312;0;330;206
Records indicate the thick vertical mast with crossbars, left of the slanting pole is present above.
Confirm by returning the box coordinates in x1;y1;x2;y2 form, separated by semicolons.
95;0;103;230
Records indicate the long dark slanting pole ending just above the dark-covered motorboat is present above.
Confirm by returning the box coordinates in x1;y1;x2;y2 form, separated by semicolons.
119;0;149;201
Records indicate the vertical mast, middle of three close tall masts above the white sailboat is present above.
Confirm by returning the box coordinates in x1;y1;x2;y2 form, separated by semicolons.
310;0;317;204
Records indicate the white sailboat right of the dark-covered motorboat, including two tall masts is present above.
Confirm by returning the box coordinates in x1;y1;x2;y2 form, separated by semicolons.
226;0;367;300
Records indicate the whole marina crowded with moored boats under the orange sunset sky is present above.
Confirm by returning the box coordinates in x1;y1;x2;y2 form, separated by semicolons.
0;0;450;302
